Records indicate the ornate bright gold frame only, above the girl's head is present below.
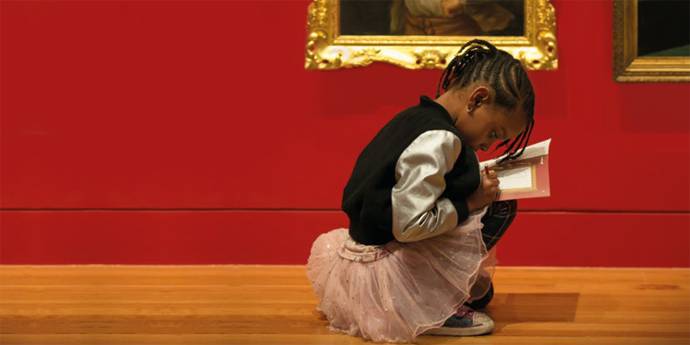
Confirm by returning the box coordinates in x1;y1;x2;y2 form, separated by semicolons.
304;0;558;70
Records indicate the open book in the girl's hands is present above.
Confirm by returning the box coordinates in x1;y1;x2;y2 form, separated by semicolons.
479;139;551;200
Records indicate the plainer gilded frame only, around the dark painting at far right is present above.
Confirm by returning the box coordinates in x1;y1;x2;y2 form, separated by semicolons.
613;0;690;82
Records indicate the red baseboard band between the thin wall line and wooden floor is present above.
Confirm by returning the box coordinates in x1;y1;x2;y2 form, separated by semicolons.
0;210;690;267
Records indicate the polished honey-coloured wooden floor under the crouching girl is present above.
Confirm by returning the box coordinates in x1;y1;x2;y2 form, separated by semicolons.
0;265;690;345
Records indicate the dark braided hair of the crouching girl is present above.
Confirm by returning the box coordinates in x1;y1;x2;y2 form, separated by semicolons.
436;39;534;163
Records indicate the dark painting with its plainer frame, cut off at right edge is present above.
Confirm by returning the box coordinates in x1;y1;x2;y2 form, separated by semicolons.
613;0;690;82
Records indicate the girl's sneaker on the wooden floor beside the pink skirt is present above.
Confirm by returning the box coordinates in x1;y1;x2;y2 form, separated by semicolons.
424;306;494;336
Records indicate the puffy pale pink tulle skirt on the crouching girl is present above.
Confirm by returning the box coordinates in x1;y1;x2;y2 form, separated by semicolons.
307;208;495;342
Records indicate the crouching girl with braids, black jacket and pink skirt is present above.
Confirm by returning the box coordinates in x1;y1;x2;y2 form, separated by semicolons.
307;40;534;342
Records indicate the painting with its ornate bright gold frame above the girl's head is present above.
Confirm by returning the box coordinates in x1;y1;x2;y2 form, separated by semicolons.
304;0;558;70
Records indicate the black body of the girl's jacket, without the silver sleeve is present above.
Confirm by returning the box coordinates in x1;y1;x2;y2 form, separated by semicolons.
342;96;480;245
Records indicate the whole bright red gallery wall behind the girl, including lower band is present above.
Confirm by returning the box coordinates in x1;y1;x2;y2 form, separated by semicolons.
0;1;690;267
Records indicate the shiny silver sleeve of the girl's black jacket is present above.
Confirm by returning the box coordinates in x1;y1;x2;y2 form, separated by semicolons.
391;130;462;242
